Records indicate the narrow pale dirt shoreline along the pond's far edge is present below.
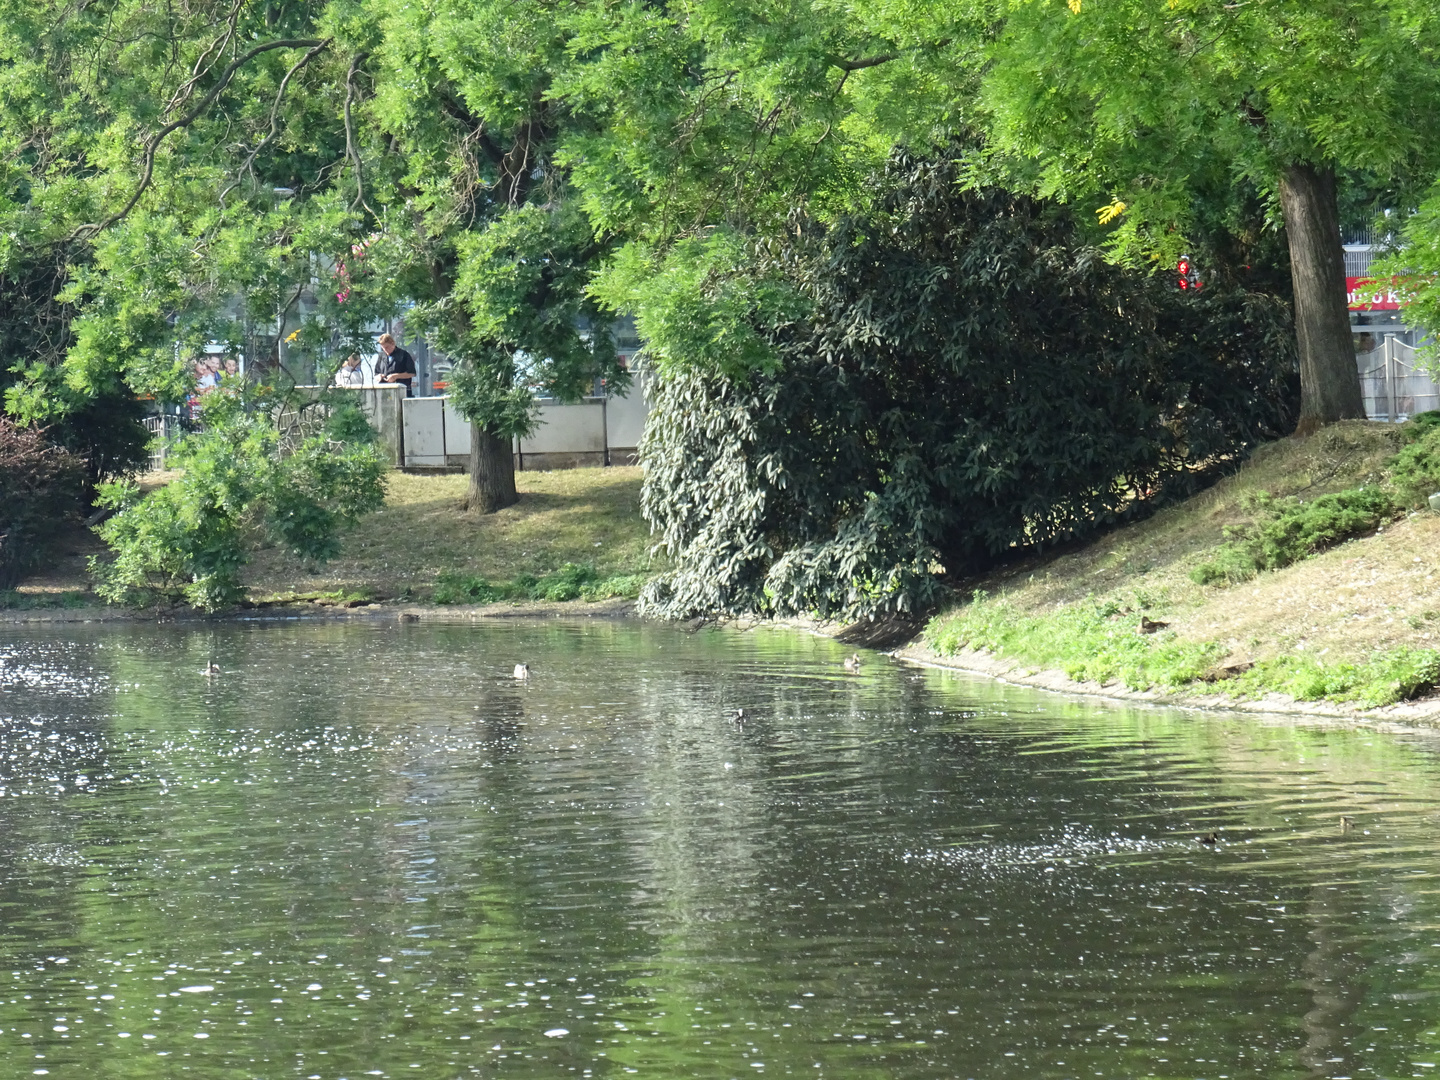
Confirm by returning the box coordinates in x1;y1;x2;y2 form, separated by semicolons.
11;599;1440;732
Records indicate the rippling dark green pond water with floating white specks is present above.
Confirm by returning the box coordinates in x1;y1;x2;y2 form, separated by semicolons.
0;621;1440;1080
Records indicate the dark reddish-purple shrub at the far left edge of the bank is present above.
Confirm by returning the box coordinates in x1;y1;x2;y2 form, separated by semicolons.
0;415;84;589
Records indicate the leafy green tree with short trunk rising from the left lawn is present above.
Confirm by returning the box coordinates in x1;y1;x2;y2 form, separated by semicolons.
363;0;626;513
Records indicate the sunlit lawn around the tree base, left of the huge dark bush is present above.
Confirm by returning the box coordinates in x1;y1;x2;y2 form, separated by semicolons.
245;467;655;602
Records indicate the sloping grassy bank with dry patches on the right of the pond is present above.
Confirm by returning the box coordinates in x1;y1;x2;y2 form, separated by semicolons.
924;422;1440;720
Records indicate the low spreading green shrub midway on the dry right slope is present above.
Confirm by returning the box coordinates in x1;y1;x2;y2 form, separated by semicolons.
1191;487;1395;585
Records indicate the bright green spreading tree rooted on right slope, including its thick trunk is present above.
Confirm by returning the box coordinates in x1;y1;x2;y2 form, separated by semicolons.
550;0;1440;429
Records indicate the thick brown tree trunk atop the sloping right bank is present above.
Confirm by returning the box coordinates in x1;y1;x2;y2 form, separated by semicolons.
1280;164;1365;435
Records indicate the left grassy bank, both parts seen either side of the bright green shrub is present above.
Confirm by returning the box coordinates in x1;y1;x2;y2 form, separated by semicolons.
0;467;652;609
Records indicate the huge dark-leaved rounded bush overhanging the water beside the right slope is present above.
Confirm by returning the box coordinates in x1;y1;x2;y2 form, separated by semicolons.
642;156;1295;618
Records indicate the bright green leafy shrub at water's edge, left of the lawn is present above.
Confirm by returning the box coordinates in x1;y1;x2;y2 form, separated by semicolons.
91;392;386;611
